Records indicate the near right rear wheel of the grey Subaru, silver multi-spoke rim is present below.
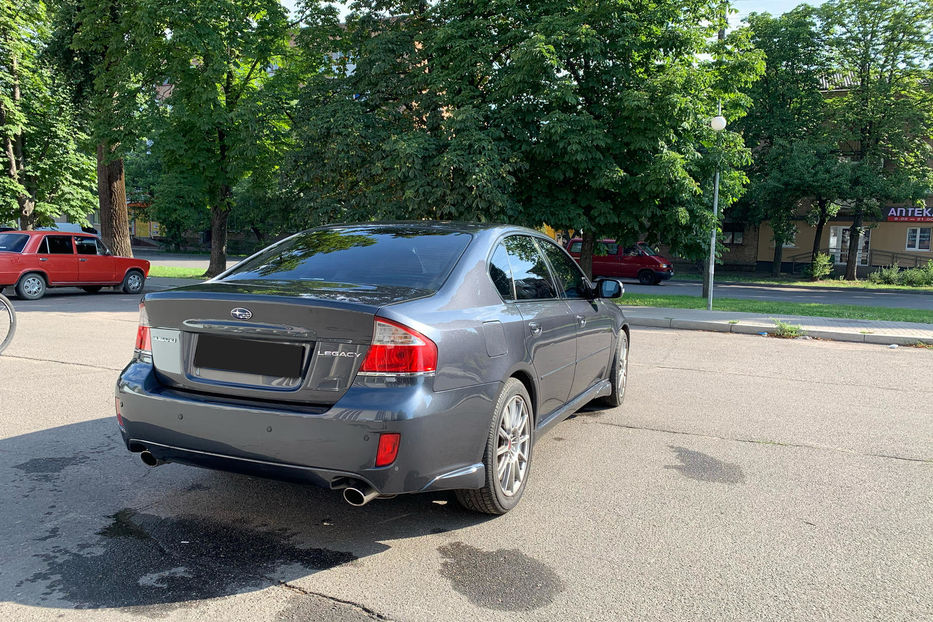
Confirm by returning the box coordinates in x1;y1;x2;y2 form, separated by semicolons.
457;378;535;514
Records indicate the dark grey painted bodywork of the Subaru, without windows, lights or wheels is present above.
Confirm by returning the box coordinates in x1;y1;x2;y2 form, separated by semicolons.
117;223;624;494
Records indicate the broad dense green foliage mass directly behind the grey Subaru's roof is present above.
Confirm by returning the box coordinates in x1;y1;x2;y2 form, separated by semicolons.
288;0;762;278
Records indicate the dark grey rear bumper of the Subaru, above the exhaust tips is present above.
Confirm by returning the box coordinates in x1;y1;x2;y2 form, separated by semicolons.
116;361;501;494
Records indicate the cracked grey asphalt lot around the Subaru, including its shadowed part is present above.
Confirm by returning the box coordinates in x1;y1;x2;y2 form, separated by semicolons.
0;293;933;621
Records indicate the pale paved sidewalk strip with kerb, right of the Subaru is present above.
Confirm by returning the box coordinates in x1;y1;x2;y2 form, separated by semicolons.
619;305;933;345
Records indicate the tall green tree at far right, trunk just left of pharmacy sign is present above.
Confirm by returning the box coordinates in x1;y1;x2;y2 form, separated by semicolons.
822;0;933;280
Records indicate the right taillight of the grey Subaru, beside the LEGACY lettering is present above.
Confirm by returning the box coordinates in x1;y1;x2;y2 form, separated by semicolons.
360;318;437;374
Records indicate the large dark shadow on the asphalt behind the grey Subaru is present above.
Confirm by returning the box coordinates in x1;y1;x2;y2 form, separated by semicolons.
0;417;489;615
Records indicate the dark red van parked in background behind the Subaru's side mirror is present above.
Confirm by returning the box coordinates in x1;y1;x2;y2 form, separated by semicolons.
567;238;674;285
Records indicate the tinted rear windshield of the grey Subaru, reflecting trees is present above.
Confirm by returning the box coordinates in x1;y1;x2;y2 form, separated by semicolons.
223;227;472;291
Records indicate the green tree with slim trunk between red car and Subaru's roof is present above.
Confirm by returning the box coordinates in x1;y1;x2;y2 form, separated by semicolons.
136;0;295;276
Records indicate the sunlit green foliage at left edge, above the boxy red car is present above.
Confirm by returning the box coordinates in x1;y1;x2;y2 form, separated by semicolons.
0;0;94;229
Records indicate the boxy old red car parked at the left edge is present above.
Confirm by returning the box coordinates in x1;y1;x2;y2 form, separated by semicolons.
0;231;149;300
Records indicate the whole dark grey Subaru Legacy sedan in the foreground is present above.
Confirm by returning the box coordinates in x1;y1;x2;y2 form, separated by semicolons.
116;222;629;514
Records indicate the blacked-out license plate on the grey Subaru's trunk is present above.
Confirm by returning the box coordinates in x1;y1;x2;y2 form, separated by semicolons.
194;335;304;378
